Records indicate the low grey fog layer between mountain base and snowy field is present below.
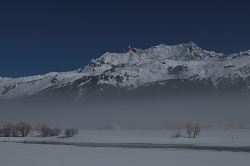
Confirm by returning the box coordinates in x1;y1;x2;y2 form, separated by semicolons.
0;94;250;129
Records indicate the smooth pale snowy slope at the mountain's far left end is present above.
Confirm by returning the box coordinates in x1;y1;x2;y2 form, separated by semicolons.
0;72;82;99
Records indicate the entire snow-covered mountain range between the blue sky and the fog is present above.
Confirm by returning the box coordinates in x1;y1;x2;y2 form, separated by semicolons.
0;42;250;100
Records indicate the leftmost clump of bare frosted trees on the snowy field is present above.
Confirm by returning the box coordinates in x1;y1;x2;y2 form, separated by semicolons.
0;122;34;137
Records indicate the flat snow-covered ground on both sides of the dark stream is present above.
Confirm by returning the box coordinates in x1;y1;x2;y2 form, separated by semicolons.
0;130;250;166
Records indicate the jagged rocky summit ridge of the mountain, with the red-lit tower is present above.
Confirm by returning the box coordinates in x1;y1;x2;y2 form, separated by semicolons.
79;42;221;72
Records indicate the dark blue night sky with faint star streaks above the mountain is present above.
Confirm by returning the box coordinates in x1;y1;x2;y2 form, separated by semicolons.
0;0;250;77
